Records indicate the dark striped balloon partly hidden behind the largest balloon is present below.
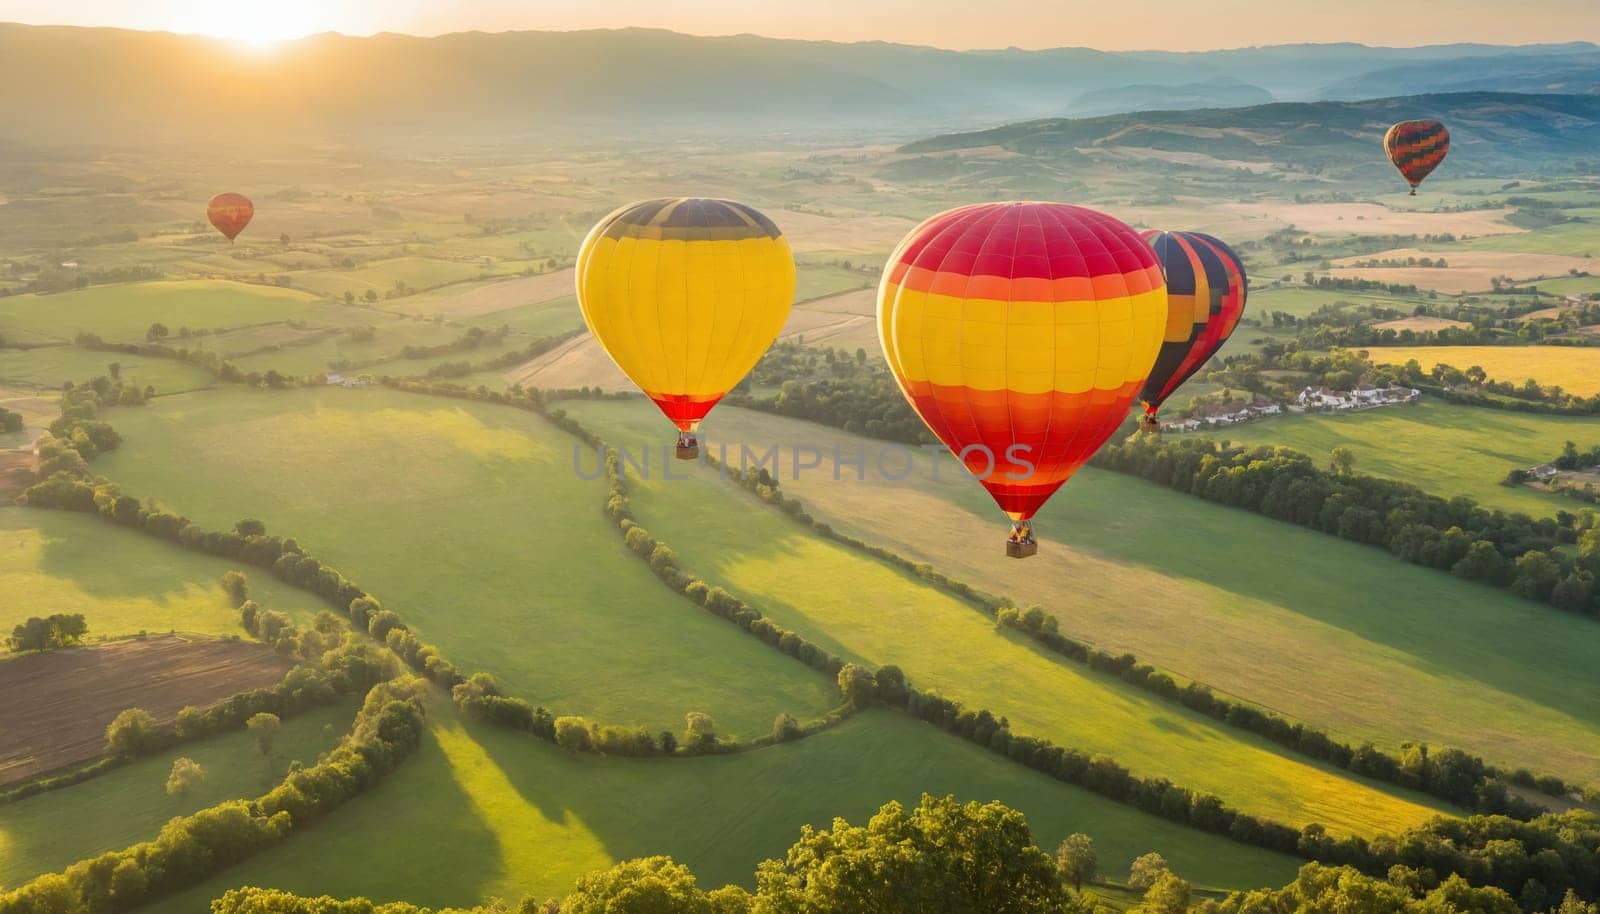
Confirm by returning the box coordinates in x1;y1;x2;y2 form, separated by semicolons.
1139;232;1248;431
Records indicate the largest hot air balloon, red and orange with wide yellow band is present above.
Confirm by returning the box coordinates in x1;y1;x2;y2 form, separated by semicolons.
878;203;1166;557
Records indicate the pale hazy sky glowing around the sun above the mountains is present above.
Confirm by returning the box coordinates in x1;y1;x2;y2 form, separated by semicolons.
0;0;1600;50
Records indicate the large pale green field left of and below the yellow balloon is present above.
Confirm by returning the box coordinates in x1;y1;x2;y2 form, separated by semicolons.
94;387;837;736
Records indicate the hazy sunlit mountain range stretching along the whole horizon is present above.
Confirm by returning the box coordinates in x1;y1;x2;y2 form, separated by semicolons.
0;24;1600;144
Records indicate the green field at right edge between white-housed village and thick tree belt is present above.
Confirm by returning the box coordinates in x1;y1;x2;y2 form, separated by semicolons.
1218;398;1600;517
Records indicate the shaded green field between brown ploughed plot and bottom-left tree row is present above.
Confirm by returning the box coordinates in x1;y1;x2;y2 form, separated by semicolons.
0;703;355;890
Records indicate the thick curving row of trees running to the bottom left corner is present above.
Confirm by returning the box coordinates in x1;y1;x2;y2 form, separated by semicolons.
0;679;426;914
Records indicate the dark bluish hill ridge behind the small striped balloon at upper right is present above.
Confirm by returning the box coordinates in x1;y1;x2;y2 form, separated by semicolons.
901;93;1600;174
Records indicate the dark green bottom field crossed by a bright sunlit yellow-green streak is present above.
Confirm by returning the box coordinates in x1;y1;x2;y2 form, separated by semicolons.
150;708;1298;914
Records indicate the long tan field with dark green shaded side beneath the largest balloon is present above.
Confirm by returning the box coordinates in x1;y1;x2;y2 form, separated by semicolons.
570;402;1600;793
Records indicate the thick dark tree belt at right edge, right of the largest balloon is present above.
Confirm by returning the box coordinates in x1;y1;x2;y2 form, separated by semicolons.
1093;435;1600;615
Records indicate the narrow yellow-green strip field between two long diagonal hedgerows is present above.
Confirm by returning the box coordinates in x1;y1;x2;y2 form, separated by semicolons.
560;403;1435;834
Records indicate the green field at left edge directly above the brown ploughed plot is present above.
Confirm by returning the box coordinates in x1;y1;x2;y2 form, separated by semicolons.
0;507;330;643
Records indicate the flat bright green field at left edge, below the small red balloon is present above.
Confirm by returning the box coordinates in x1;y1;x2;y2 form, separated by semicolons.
0;280;326;341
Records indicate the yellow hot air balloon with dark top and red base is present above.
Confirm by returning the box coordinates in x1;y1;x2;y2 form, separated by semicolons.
578;197;795;459
